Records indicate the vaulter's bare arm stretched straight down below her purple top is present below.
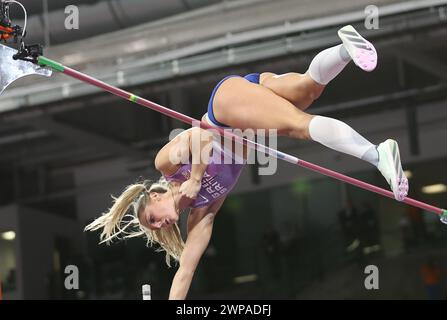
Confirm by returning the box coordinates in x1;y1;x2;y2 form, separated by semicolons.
169;197;225;300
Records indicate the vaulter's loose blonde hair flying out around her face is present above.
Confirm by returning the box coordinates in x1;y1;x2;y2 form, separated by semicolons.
84;176;185;267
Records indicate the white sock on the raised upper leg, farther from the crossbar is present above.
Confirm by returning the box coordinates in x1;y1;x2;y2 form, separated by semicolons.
307;44;351;85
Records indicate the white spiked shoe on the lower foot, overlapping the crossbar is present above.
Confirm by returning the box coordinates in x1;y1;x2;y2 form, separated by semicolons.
377;139;408;201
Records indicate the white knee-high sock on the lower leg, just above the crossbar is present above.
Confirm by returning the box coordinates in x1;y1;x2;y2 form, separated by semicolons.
309;116;379;167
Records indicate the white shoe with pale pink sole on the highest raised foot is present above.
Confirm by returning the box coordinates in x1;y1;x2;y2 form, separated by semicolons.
338;25;377;72
